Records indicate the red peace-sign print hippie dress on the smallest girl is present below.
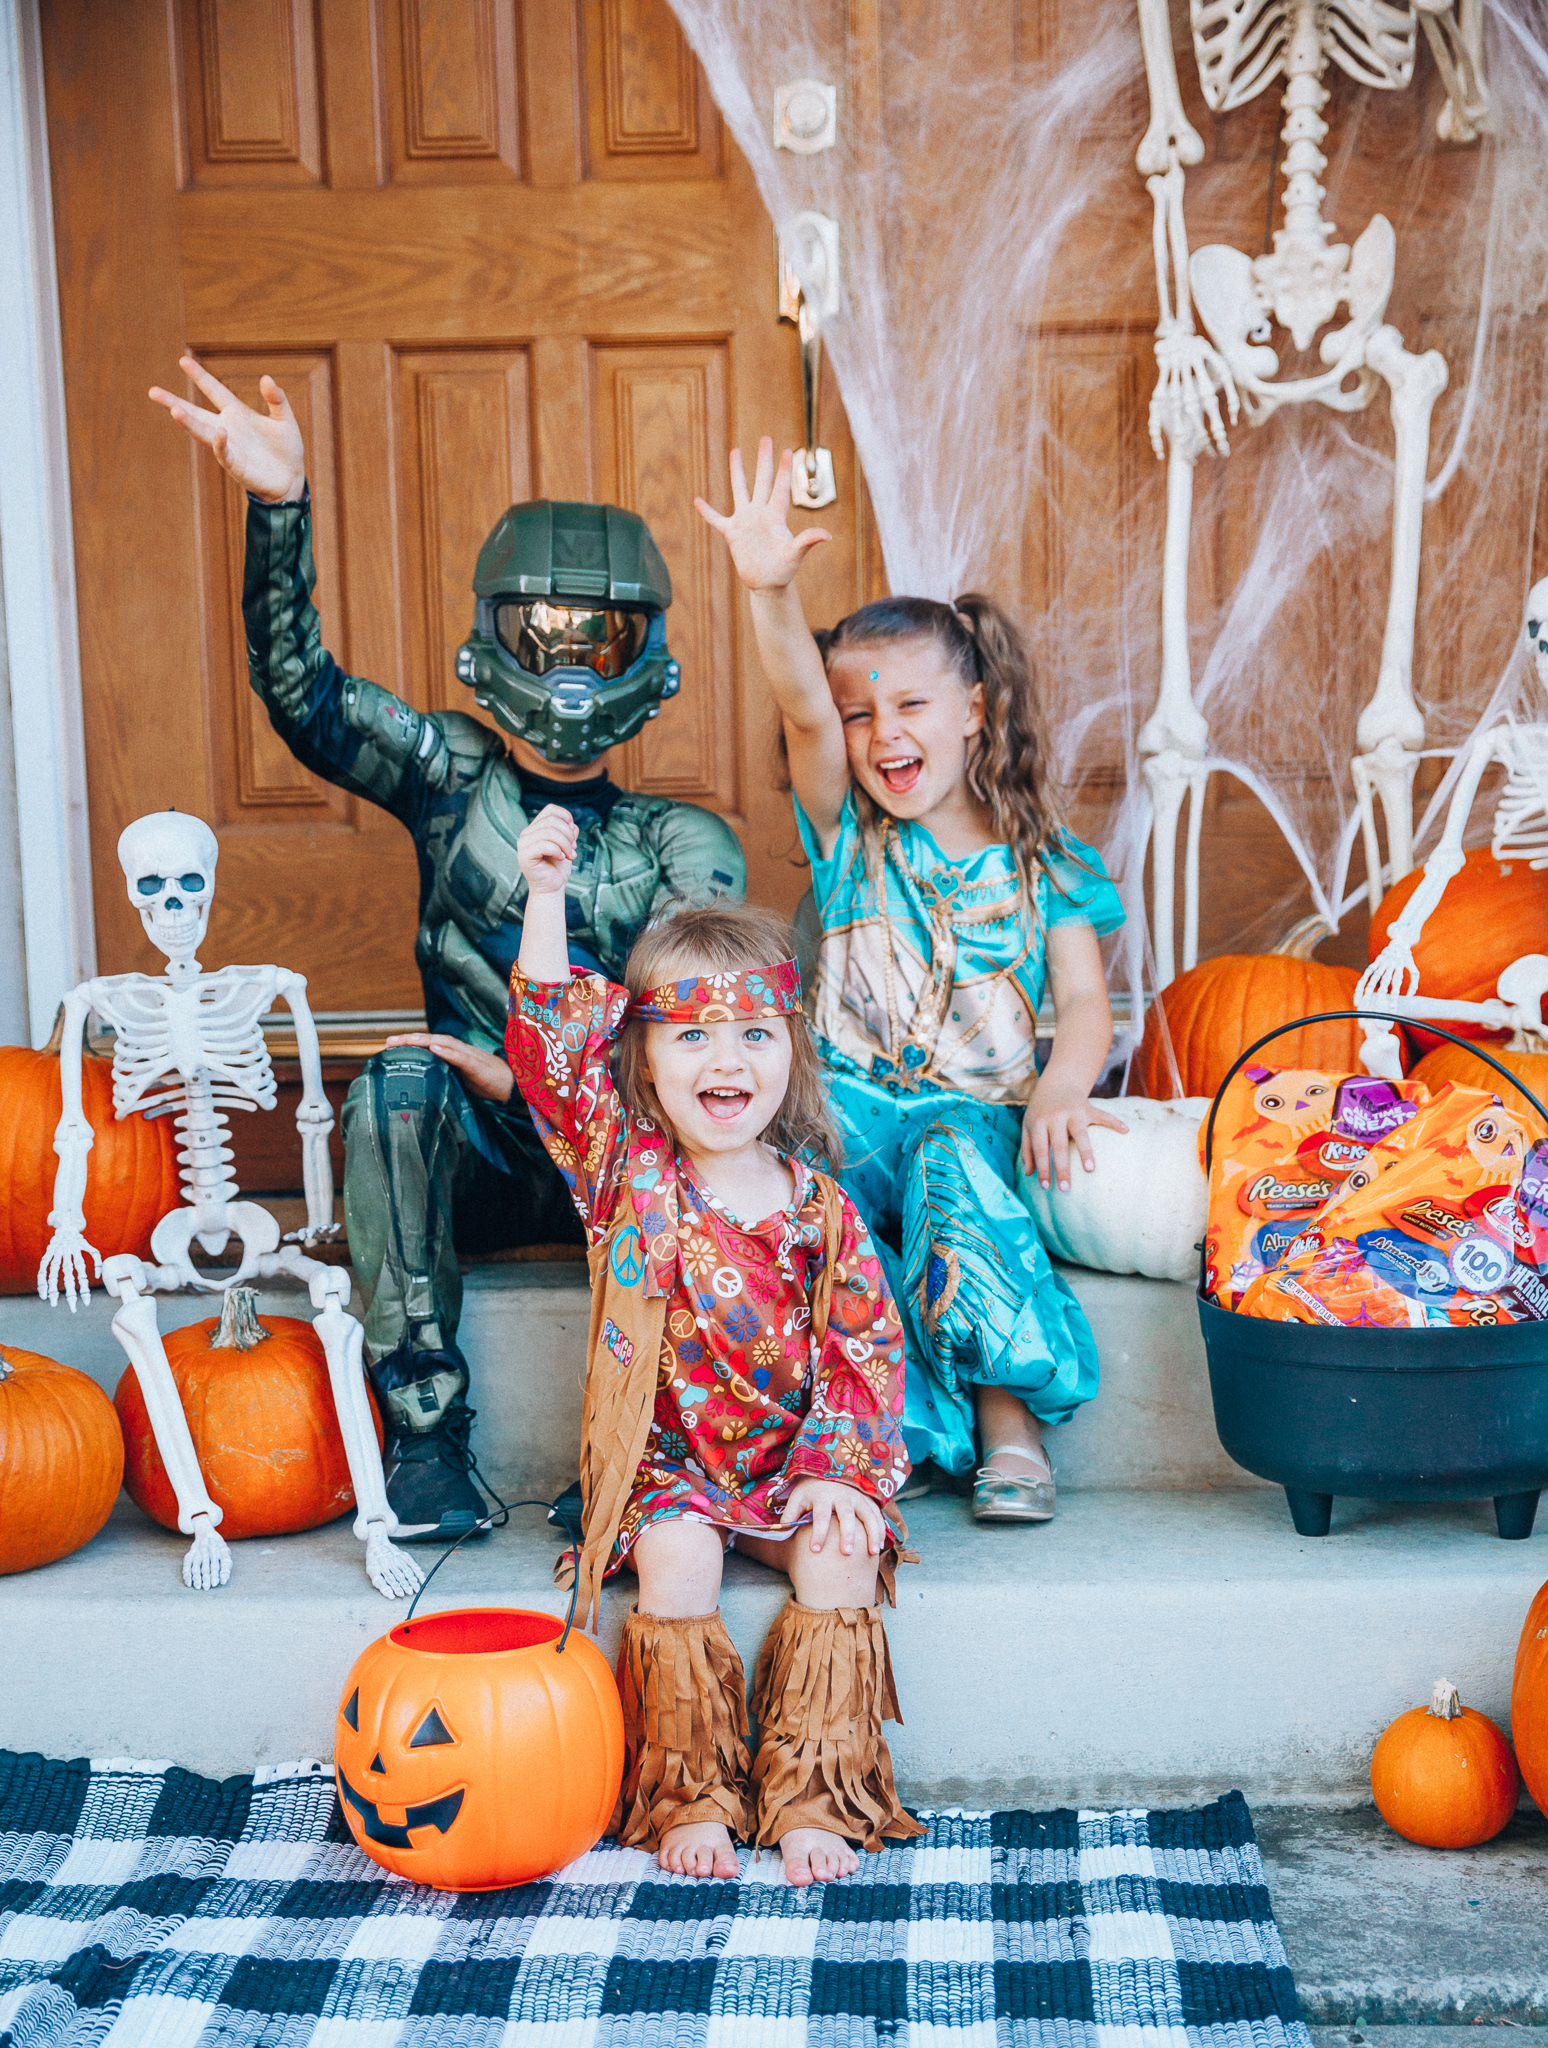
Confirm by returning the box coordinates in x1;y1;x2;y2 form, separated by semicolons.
506;969;909;1573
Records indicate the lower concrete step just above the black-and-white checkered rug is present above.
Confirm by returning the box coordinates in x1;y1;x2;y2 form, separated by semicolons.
0;1487;1548;1806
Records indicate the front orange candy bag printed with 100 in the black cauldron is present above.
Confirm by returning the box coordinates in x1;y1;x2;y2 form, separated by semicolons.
1237;1083;1548;1329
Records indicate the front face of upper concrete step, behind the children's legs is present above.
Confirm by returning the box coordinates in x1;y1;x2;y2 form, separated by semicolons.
0;1262;1261;1495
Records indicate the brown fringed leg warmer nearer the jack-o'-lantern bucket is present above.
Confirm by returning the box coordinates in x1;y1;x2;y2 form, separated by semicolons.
612;1610;749;1849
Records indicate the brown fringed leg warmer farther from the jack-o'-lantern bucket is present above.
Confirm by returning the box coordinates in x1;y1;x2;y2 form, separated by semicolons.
751;1599;923;1849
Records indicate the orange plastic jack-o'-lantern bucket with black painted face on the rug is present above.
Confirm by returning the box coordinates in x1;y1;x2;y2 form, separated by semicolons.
334;1608;622;1892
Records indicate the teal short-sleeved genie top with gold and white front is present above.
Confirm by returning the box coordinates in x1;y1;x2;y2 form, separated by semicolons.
794;791;1124;1102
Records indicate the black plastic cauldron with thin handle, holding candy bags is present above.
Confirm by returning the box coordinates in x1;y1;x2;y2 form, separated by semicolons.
1198;1010;1548;1538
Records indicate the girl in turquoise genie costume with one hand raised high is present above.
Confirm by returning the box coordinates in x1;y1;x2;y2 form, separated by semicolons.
698;440;1126;1522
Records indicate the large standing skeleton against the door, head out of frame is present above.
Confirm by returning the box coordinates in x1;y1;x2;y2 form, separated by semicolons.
1136;0;1493;985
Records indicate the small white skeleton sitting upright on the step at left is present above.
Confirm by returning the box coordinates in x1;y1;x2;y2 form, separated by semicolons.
37;811;420;1599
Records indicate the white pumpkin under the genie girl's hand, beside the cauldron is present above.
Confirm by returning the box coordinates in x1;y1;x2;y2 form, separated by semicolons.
1016;1096;1210;1280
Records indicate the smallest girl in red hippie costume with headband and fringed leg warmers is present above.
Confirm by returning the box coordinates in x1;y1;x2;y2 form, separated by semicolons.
506;805;919;1884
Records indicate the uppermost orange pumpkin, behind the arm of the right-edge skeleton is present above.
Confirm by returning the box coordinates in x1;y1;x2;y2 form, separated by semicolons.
1370;846;1548;1047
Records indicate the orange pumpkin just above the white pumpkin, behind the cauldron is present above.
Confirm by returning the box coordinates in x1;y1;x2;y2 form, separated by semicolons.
1128;952;1364;1102
